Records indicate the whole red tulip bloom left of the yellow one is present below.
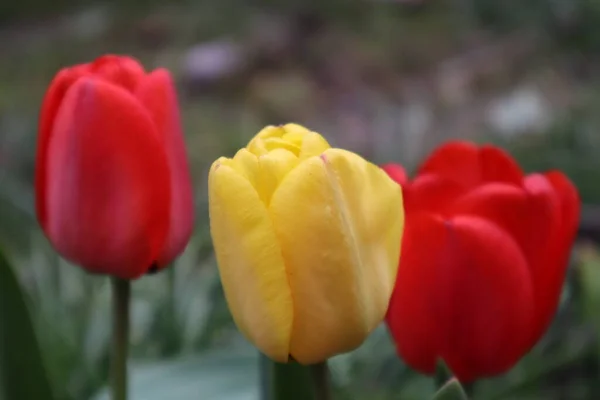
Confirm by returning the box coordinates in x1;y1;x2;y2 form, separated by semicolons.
35;55;193;279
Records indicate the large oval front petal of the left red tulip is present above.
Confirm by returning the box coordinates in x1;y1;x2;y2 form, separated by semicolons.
41;78;170;279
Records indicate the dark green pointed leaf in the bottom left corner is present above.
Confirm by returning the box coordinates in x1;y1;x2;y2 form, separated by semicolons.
0;251;54;400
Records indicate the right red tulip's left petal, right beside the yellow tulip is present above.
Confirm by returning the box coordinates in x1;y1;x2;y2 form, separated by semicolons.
386;213;447;374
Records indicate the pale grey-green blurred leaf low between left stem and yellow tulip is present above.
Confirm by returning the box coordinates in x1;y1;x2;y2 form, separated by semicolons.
94;346;260;400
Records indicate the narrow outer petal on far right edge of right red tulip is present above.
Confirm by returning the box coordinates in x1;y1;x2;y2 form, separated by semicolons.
532;171;581;343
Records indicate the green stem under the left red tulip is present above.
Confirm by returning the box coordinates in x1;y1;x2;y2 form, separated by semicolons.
111;278;131;400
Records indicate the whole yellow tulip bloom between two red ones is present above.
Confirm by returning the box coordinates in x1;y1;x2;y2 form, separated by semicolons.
209;124;404;364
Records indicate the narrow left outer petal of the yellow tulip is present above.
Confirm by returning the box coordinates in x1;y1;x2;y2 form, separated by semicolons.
208;159;293;362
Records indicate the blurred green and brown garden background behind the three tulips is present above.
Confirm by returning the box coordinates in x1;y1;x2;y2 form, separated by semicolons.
0;0;600;400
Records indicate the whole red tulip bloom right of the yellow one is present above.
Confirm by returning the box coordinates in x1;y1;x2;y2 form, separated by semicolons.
384;142;580;382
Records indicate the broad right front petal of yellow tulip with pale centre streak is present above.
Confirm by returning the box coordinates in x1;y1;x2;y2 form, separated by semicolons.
269;149;404;364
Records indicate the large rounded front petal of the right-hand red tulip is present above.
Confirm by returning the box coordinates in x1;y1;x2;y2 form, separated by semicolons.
436;216;533;382
